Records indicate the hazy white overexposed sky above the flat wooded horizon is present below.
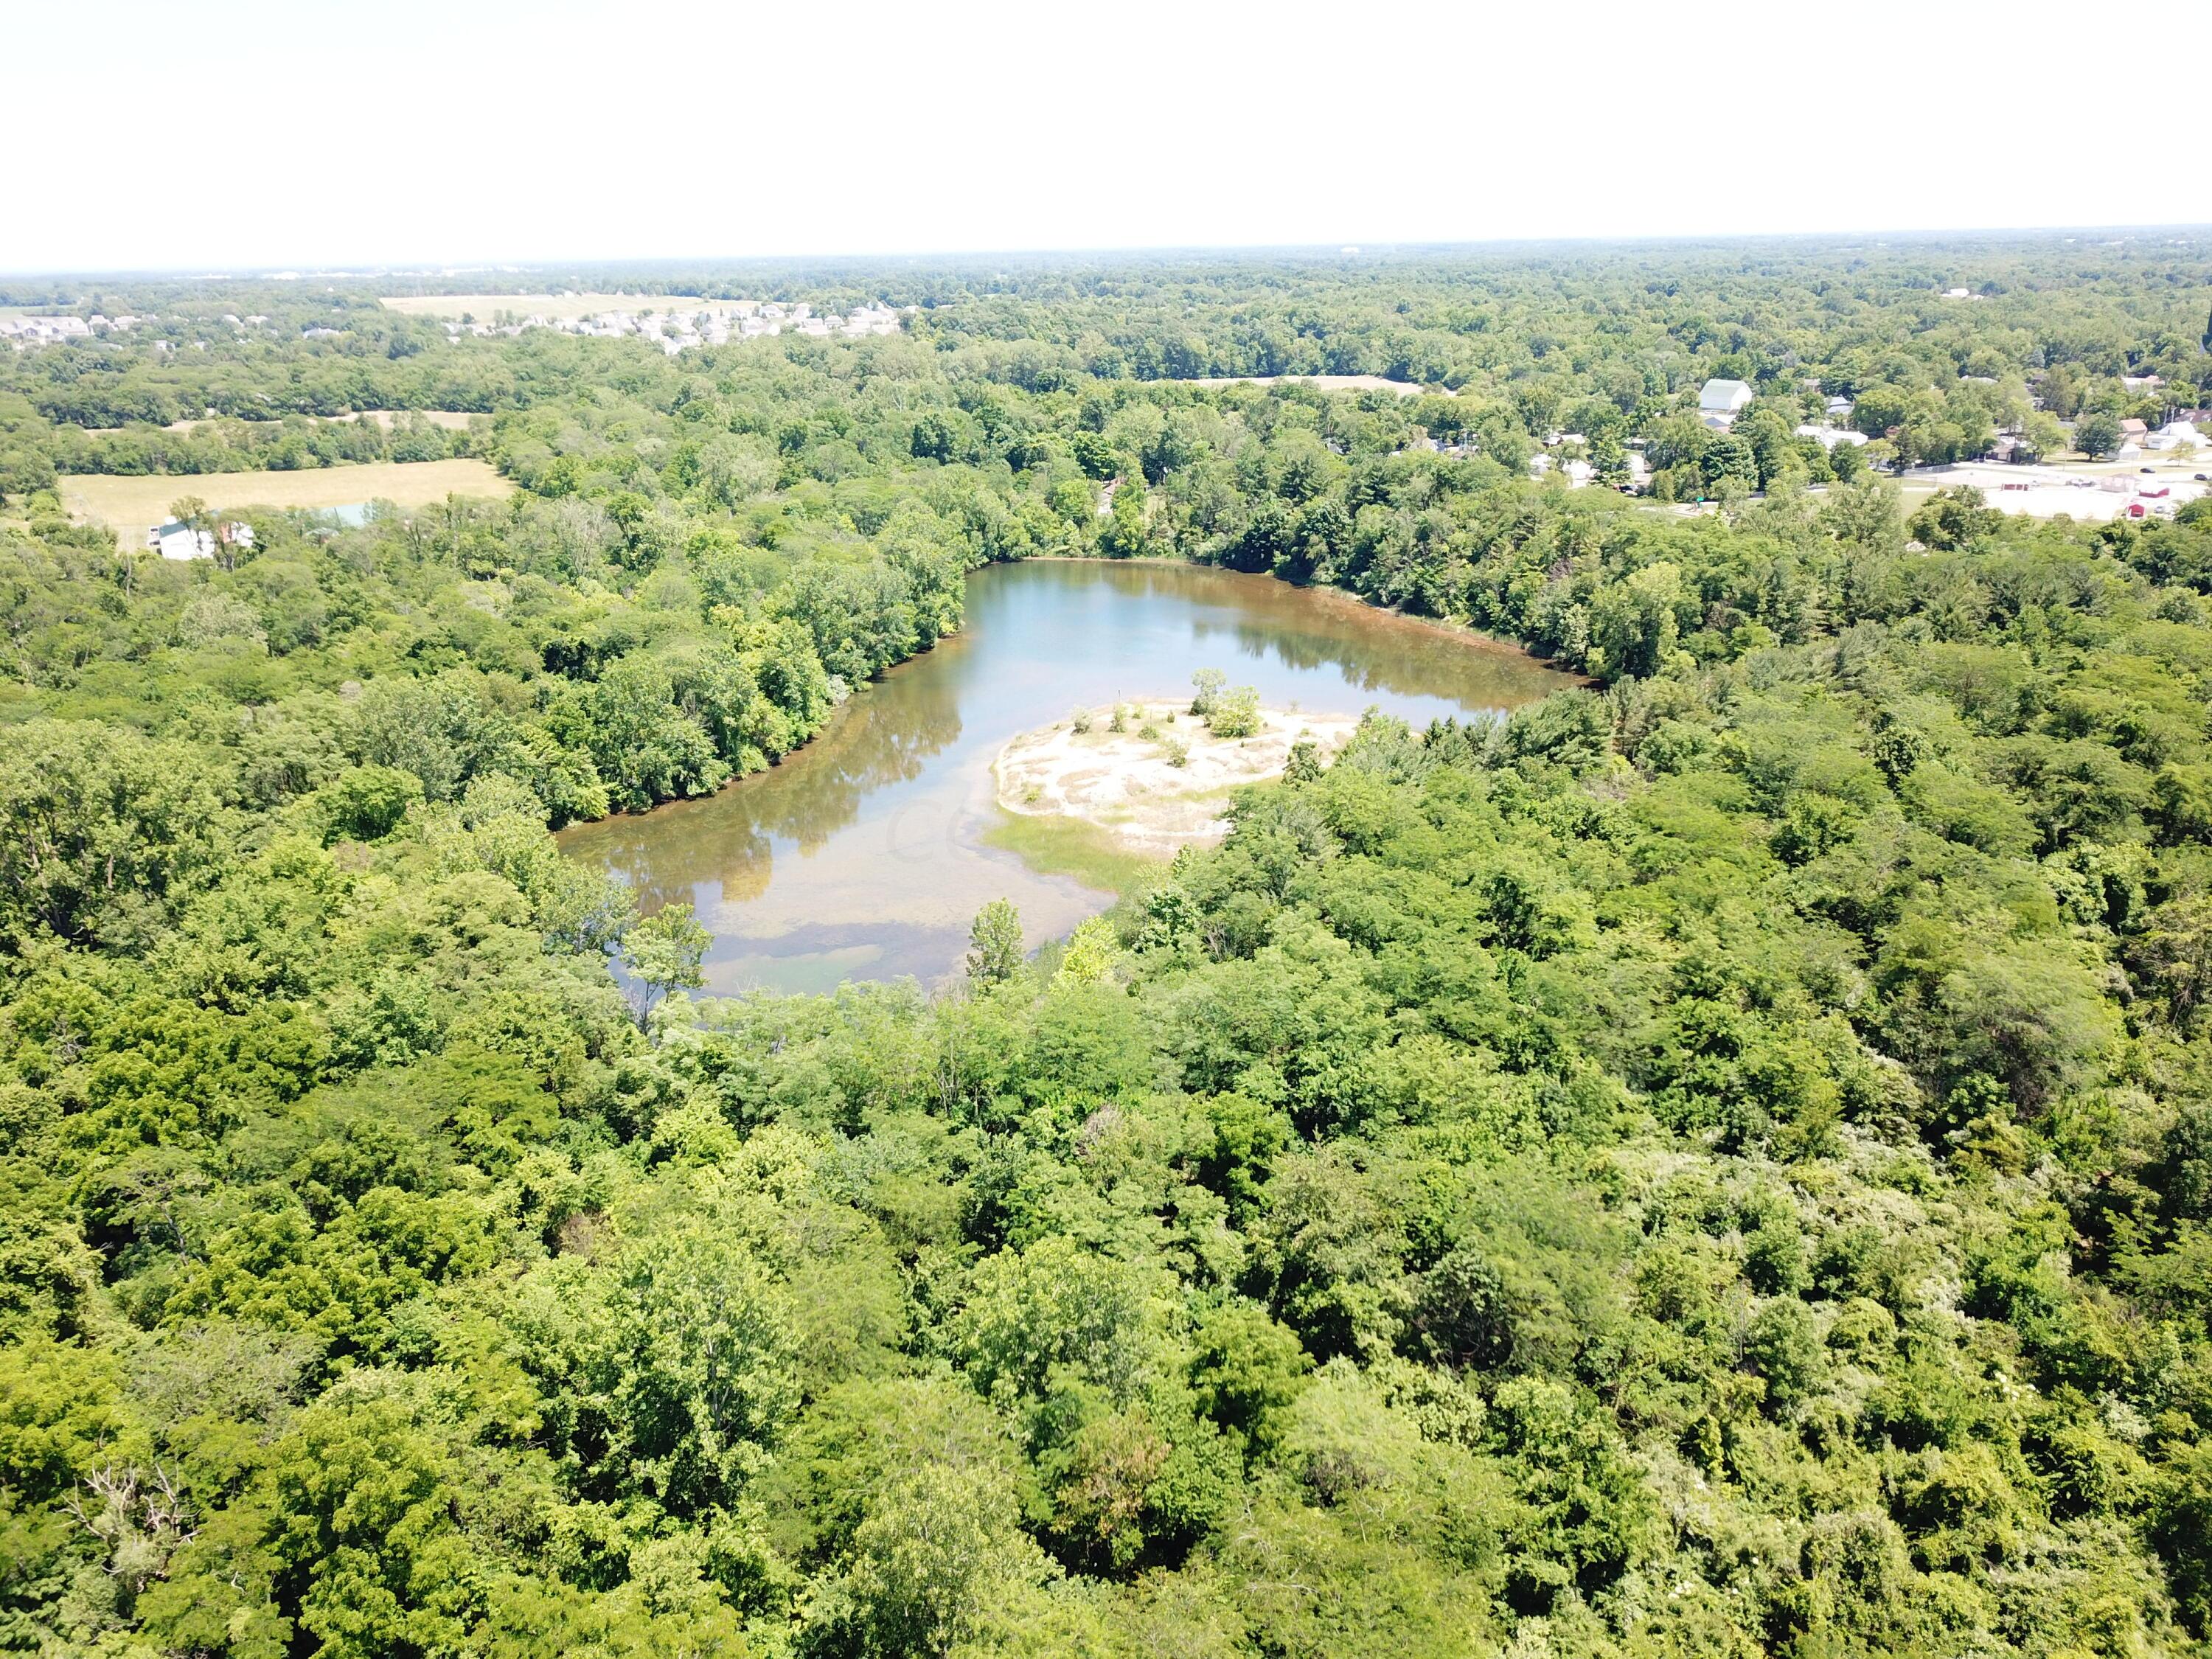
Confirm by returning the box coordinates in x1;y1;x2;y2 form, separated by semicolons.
0;0;2212;272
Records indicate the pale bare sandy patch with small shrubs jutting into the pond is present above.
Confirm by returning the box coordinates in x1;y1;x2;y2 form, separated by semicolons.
993;699;1358;856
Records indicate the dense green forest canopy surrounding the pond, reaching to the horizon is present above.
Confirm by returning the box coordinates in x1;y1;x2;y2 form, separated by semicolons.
13;237;2212;1659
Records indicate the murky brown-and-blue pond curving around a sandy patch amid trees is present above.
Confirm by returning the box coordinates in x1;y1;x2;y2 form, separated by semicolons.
560;560;1573;993
